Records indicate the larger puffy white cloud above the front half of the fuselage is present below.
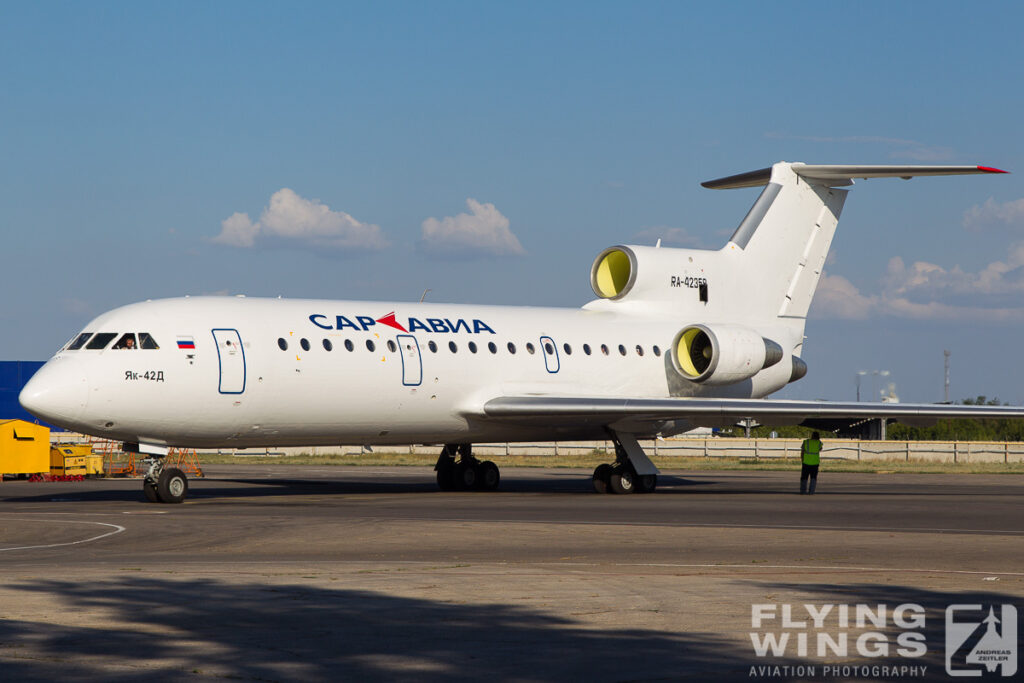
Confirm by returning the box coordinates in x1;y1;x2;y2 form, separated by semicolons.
210;187;388;250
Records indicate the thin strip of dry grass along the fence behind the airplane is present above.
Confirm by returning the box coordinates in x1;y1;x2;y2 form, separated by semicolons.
193;453;1024;474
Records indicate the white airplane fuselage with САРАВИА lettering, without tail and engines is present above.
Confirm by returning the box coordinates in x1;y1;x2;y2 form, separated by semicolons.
22;297;802;447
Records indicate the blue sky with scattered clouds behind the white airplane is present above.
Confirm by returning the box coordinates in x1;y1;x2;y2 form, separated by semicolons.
0;2;1024;403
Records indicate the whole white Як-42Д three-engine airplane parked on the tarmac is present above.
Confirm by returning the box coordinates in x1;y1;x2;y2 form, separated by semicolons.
19;162;1024;503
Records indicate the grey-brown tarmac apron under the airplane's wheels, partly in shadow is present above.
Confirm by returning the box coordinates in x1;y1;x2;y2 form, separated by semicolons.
0;463;1024;681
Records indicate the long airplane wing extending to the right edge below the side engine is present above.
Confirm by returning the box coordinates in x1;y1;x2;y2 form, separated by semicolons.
483;396;1024;424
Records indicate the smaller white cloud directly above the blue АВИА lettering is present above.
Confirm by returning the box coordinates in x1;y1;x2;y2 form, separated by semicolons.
420;199;526;258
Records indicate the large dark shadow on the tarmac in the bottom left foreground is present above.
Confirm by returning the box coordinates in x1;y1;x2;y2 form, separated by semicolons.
0;575;761;681
